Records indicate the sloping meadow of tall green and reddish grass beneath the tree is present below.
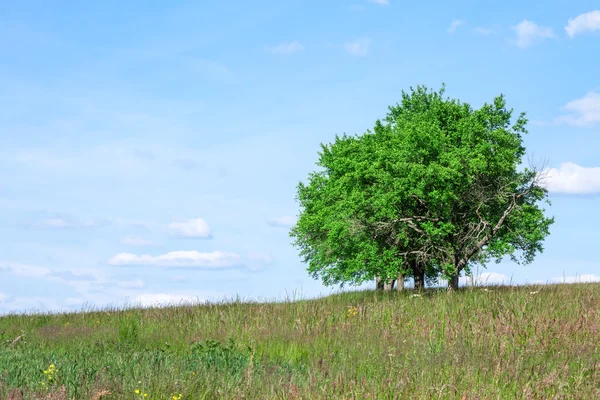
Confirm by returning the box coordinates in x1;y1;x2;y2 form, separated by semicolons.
0;284;600;400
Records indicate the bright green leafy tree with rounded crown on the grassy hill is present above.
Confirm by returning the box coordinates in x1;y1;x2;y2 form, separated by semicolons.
291;87;553;288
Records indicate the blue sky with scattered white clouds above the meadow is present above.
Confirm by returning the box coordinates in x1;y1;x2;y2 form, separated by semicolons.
0;0;600;314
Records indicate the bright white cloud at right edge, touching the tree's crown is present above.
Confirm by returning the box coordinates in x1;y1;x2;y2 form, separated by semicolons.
545;162;600;194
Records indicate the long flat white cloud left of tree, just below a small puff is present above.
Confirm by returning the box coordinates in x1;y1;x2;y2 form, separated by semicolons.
108;250;242;268
